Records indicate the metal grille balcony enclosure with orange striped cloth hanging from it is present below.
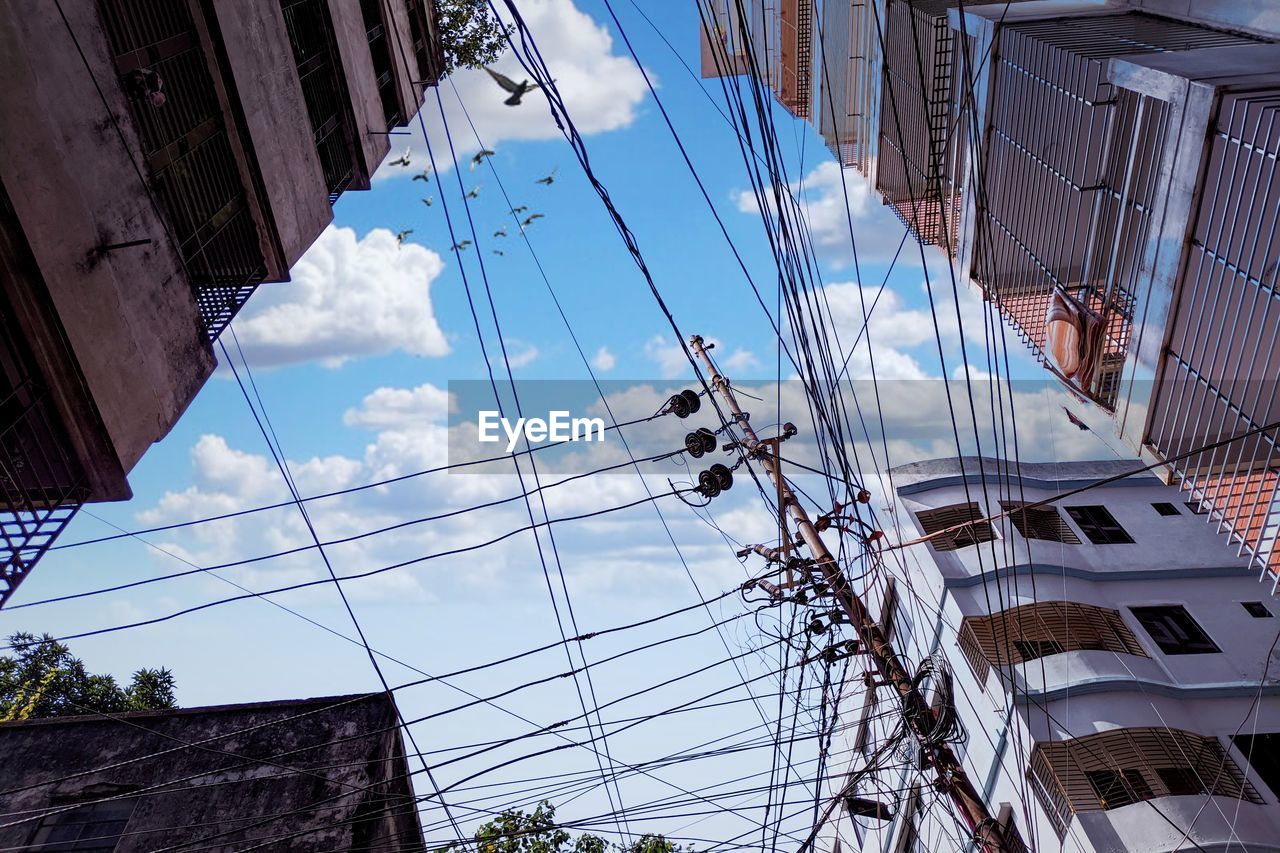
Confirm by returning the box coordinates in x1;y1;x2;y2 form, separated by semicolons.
973;13;1257;407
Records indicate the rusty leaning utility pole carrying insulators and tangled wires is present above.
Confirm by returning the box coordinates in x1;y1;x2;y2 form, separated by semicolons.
689;334;1009;853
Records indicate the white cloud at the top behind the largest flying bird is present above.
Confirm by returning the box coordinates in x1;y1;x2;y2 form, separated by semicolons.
378;0;652;178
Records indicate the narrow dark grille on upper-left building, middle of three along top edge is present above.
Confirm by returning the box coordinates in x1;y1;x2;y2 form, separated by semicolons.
280;0;356;202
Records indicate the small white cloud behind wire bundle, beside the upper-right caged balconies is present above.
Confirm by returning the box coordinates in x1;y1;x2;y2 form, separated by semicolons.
736;160;921;269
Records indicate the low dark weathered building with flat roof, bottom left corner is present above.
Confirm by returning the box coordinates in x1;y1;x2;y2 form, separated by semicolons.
0;693;424;853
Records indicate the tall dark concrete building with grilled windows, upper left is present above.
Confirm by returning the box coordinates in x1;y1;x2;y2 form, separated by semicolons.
0;0;443;606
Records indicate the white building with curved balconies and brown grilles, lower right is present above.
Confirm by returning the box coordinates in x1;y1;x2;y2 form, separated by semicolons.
818;457;1280;853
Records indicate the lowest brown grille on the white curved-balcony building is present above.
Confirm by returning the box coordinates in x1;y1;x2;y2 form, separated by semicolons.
1029;727;1263;834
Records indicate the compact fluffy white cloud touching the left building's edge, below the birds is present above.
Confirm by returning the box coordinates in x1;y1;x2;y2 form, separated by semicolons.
236;225;449;366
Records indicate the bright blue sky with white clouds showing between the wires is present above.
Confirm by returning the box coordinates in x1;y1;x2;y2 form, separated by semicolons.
4;0;1107;838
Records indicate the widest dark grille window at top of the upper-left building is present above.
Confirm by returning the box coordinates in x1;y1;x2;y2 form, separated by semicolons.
99;0;266;338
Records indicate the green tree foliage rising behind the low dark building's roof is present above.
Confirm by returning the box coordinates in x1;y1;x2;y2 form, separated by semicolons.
0;631;178;721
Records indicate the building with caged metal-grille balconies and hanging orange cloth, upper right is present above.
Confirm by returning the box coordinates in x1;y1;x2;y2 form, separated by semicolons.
701;0;1280;590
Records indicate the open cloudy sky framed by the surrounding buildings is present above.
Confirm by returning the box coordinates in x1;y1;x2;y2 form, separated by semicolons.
3;0;1112;841
